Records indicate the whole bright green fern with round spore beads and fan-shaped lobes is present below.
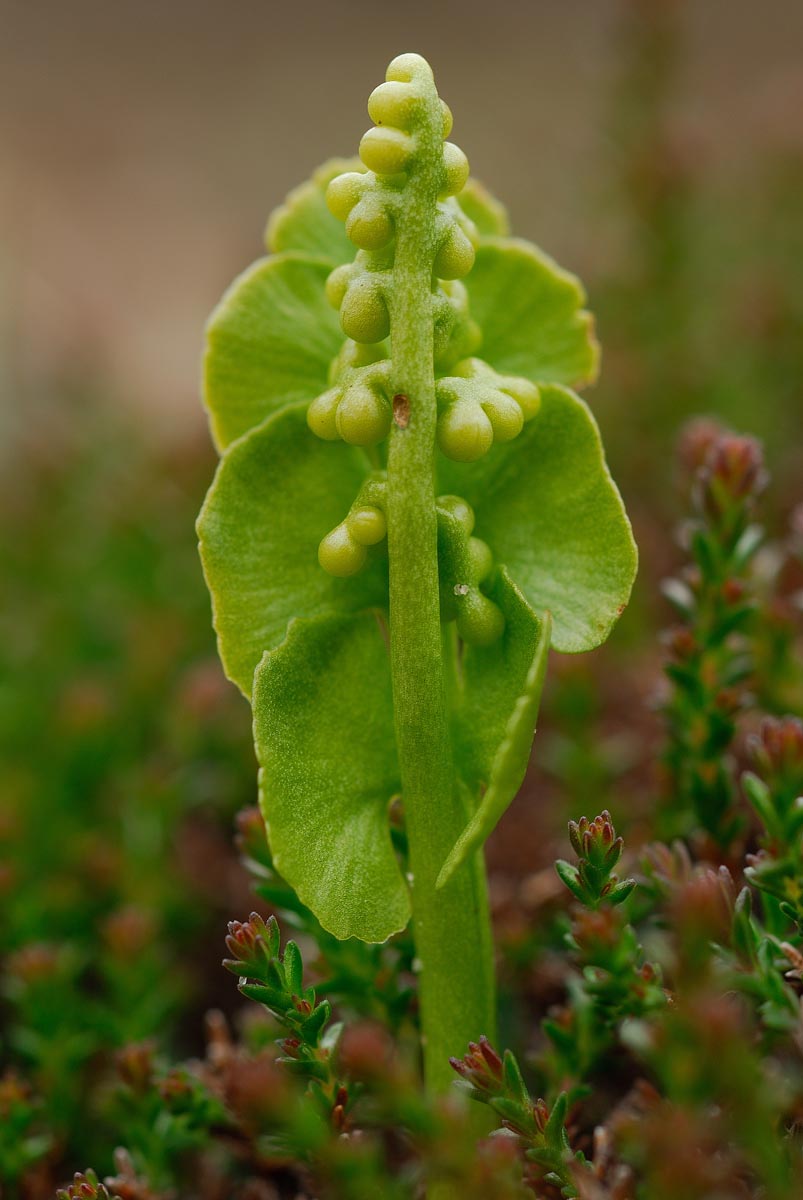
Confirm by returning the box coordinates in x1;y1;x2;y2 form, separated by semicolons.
198;54;636;1091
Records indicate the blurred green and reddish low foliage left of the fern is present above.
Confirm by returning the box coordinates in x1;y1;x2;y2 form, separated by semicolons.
0;394;253;1180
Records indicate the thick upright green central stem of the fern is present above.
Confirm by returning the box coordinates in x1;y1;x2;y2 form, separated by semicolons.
388;86;495;1092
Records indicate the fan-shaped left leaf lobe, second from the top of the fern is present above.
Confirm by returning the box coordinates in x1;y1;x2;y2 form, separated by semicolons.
204;254;343;450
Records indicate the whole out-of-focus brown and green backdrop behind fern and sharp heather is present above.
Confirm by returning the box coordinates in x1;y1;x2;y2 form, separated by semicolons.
0;0;803;1194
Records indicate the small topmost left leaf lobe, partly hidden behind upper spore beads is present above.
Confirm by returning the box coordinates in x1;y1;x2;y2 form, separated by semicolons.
265;158;365;266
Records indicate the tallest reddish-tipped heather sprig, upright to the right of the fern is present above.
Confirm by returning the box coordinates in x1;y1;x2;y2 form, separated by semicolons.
664;421;766;850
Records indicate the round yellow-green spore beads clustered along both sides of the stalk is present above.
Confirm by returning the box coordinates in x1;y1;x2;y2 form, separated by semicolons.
307;54;540;643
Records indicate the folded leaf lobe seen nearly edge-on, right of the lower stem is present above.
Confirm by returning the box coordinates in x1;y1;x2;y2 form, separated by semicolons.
438;585;551;888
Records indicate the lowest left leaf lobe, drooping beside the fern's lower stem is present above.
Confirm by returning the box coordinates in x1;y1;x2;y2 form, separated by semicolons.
253;613;411;942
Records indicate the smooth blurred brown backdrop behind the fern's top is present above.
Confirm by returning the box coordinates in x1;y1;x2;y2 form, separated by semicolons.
0;0;803;441
